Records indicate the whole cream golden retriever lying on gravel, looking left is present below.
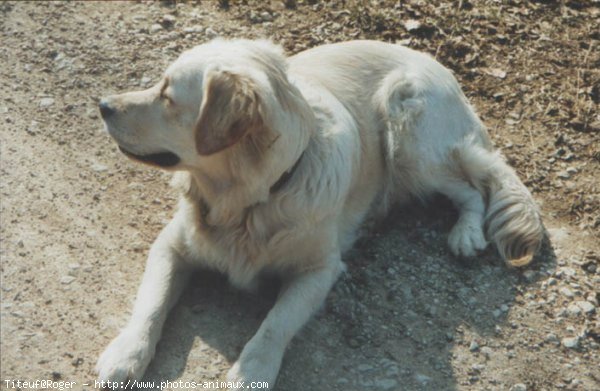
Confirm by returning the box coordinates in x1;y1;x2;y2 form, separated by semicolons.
97;39;543;389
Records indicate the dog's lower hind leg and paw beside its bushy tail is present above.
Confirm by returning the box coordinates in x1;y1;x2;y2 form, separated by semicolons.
437;178;487;257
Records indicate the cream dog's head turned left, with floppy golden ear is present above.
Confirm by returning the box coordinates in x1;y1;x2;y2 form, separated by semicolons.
100;40;307;176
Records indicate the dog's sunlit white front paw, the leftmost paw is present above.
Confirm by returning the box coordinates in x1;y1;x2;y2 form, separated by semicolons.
96;329;154;383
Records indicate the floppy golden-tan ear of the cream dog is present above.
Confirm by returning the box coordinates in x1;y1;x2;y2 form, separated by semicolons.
196;70;262;155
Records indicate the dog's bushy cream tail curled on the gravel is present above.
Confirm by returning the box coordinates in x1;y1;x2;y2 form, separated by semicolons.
460;143;544;266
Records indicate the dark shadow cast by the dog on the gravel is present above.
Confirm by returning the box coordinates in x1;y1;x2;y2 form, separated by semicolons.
142;199;556;391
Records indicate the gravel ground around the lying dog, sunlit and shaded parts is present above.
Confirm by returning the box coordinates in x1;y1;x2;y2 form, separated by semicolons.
0;0;600;391
